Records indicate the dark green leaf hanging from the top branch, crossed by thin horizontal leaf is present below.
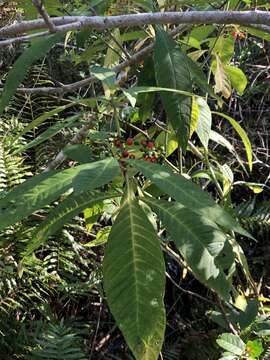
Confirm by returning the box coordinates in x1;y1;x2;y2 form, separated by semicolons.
154;27;192;151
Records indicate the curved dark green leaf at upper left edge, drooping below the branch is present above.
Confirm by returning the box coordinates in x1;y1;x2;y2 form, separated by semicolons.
0;34;63;114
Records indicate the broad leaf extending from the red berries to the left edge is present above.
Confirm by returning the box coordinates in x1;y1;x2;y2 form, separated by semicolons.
0;158;119;229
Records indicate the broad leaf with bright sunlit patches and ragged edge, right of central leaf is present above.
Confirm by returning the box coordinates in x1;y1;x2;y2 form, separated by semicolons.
142;198;234;300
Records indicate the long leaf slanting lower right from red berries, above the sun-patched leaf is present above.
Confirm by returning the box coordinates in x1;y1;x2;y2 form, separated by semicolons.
129;160;250;237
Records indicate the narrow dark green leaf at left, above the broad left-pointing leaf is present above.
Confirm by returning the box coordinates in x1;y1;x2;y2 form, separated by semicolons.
14;115;80;154
